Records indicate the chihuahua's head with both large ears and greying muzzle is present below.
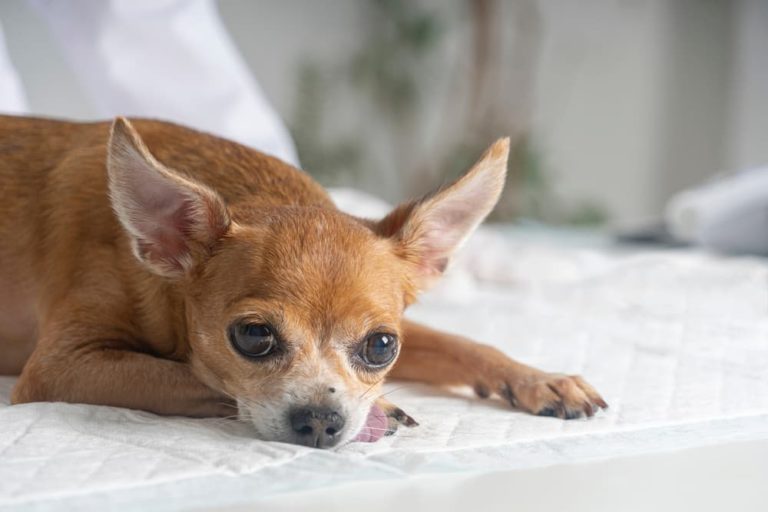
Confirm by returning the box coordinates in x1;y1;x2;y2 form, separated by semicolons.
108;119;509;447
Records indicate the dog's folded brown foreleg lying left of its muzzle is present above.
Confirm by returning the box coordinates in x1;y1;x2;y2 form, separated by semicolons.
11;340;237;417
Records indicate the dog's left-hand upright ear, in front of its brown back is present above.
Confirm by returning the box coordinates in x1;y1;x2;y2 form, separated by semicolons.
107;117;230;277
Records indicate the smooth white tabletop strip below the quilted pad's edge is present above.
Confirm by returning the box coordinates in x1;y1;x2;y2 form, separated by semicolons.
216;440;768;512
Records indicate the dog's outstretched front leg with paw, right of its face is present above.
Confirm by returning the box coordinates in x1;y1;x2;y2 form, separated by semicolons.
389;320;608;419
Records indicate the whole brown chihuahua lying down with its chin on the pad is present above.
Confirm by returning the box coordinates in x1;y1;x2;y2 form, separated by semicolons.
0;116;606;448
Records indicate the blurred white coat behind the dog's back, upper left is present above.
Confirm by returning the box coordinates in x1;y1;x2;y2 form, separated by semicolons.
0;0;299;166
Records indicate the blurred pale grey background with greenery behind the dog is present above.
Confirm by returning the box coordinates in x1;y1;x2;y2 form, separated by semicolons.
0;0;768;225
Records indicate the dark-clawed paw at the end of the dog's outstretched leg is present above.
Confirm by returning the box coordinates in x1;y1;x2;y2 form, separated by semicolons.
475;372;608;420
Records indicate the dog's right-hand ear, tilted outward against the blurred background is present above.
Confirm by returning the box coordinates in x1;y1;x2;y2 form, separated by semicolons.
376;138;509;292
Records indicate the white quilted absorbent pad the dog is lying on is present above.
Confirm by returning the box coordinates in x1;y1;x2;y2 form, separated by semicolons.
0;238;768;510
